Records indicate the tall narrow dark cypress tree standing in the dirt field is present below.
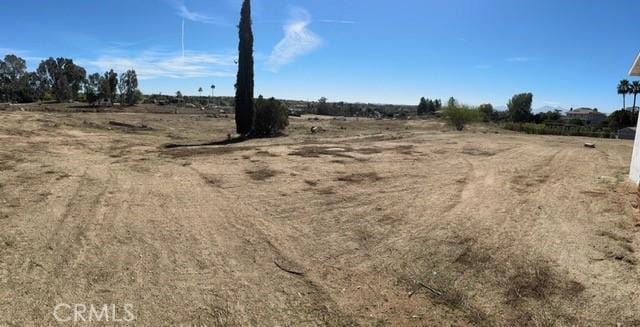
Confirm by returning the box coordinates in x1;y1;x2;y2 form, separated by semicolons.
236;0;255;135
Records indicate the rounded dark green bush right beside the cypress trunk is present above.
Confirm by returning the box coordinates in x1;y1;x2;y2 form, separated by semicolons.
252;96;289;137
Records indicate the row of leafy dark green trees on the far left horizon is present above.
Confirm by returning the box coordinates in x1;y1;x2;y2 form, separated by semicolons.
0;54;142;105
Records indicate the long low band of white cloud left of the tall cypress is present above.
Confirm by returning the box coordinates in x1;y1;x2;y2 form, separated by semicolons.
82;50;236;80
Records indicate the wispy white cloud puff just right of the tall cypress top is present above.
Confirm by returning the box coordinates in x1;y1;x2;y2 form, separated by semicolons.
267;9;322;72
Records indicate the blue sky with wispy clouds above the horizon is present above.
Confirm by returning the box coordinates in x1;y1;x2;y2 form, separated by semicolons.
0;0;640;112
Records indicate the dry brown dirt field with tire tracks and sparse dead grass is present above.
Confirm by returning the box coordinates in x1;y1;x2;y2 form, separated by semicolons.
0;112;640;326
